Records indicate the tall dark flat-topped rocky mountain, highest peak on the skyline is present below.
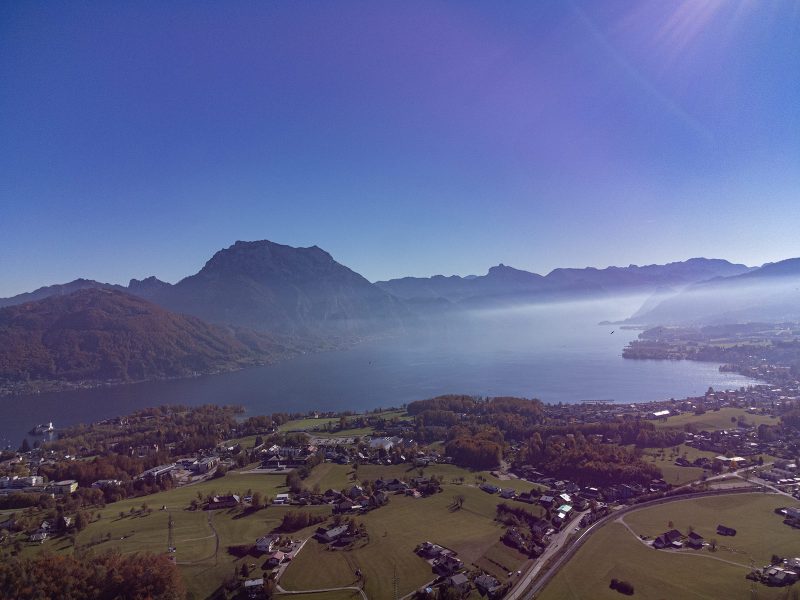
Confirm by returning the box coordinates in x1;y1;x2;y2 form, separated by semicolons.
144;240;407;337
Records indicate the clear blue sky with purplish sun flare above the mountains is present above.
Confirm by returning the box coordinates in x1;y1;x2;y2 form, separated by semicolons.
0;0;800;296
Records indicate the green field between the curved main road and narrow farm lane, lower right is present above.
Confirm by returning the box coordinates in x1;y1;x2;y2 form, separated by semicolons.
625;493;800;567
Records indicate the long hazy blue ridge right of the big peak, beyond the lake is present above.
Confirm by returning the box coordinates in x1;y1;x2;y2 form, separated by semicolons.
376;258;749;306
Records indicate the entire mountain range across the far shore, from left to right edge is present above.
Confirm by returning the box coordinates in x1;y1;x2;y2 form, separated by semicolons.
0;240;800;392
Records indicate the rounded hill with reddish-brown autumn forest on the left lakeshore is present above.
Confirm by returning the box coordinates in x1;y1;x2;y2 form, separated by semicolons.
0;287;288;382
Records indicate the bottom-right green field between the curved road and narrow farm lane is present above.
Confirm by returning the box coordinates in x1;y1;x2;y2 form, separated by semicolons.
538;522;786;600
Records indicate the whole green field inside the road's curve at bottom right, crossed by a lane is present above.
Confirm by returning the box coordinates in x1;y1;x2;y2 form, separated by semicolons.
538;494;800;600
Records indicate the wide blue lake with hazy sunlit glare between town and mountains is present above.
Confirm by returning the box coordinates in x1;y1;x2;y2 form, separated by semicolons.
0;298;753;447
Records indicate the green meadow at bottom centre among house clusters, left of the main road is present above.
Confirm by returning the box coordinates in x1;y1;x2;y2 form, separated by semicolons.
281;465;542;600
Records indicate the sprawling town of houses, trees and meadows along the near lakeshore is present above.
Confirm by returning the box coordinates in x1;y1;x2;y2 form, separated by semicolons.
0;354;800;598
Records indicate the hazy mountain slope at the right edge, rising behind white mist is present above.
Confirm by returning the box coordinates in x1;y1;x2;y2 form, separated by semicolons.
628;258;800;325
